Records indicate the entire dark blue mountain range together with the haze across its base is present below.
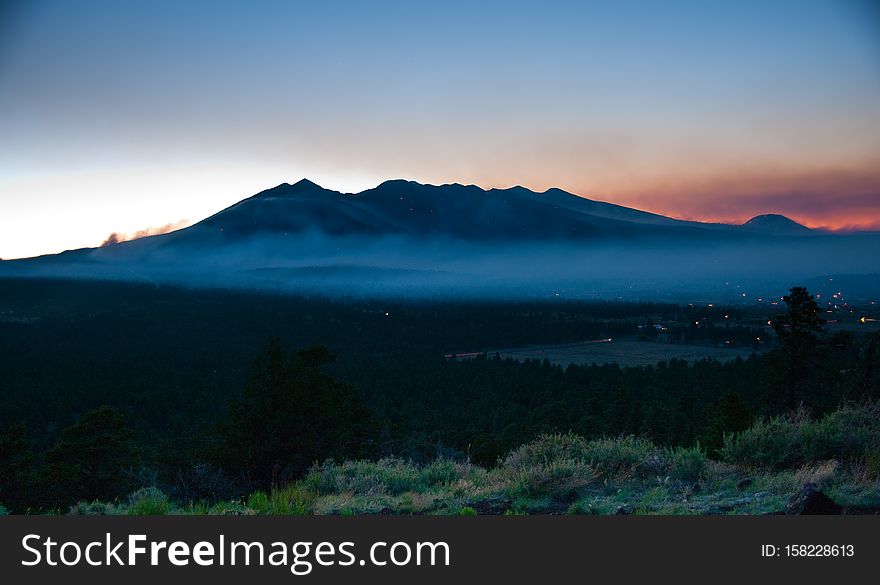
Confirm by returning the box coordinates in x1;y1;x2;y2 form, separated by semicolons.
0;179;880;300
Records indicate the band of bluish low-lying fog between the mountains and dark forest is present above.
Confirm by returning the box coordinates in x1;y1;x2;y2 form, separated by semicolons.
0;228;880;300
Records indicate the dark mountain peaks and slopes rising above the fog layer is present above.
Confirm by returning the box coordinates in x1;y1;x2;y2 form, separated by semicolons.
146;179;807;243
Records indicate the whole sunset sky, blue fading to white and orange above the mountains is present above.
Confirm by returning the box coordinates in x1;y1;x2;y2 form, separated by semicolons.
0;0;880;258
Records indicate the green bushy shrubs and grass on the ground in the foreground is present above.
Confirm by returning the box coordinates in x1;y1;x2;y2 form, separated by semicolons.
53;402;880;515
